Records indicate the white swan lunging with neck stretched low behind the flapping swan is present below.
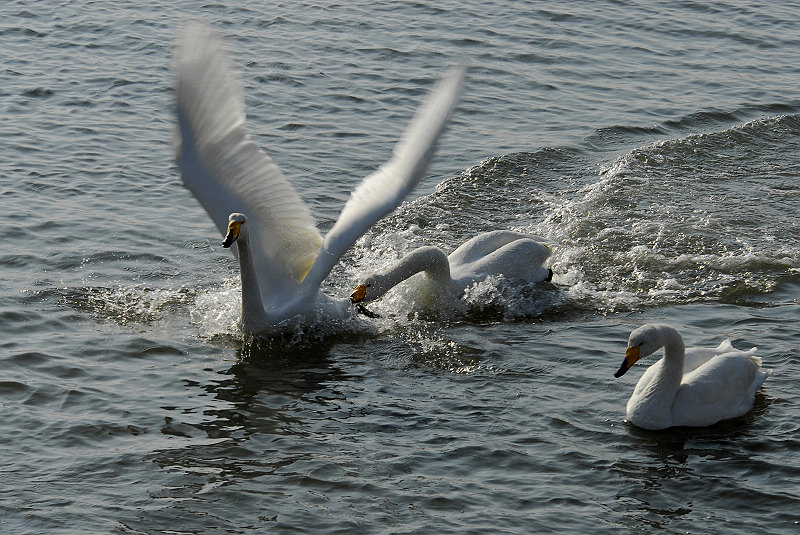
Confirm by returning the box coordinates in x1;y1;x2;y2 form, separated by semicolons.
350;230;553;310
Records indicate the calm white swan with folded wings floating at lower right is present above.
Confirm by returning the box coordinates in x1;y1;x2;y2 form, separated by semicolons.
614;324;771;430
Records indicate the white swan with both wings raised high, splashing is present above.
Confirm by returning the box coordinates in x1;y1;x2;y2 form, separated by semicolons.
174;22;465;334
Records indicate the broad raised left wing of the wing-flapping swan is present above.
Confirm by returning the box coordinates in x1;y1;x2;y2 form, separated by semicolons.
174;22;322;297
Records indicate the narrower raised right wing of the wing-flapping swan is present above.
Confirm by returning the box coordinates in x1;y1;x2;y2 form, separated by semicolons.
303;65;466;296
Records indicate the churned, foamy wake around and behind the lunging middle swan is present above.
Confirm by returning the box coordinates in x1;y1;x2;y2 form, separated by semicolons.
352;115;800;321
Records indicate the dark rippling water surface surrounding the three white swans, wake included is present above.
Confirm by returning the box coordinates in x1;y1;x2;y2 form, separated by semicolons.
0;1;800;534
